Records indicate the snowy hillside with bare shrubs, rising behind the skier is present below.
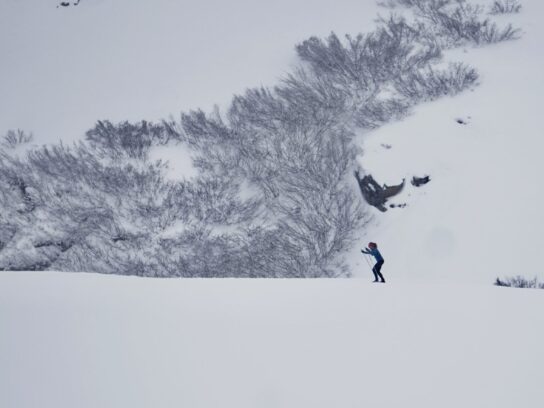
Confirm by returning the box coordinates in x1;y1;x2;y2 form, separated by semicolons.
0;2;543;283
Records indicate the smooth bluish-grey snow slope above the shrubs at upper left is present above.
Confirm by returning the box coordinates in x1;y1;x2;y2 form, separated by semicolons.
0;0;378;142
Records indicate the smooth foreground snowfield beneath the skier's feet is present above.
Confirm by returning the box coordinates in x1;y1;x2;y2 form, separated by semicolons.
0;273;544;408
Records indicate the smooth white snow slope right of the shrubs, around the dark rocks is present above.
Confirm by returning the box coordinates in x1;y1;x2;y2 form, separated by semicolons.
352;1;544;282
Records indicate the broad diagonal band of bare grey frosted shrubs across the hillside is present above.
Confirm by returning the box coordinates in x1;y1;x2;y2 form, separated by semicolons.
0;1;517;277
